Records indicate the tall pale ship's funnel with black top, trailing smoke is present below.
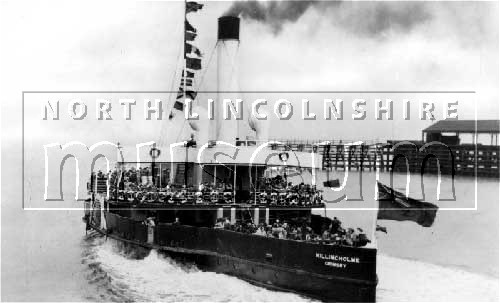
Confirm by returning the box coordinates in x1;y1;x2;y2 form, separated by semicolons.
211;16;241;144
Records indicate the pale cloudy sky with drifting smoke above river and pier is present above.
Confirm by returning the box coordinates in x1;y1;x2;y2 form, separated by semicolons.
0;1;499;148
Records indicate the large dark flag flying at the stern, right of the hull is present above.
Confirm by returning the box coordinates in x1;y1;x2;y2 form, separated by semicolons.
377;182;439;227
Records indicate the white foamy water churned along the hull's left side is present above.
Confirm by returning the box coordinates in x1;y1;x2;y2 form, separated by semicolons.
83;238;311;302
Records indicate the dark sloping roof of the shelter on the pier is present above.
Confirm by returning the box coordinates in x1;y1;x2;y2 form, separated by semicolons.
423;120;500;134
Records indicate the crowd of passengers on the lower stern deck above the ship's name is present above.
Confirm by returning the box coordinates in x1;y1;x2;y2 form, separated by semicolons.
214;217;371;247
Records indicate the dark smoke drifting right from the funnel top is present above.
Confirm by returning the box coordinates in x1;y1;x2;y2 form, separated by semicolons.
224;0;432;36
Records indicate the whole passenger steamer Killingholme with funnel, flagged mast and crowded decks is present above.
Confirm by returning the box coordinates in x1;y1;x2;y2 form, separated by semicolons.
85;2;377;302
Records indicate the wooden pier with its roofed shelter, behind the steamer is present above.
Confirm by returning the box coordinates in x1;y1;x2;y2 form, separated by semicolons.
274;120;500;178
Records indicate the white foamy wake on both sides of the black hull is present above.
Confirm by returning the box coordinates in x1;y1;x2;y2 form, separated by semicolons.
82;237;498;302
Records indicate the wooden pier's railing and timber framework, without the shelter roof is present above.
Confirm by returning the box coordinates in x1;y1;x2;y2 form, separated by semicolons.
271;140;500;178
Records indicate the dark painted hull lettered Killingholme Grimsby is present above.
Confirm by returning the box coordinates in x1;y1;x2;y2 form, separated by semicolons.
92;213;377;302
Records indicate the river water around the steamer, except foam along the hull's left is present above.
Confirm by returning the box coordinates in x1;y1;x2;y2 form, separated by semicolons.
1;151;499;301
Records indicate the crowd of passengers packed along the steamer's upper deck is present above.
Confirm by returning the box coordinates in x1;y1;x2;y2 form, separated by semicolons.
97;167;323;206
